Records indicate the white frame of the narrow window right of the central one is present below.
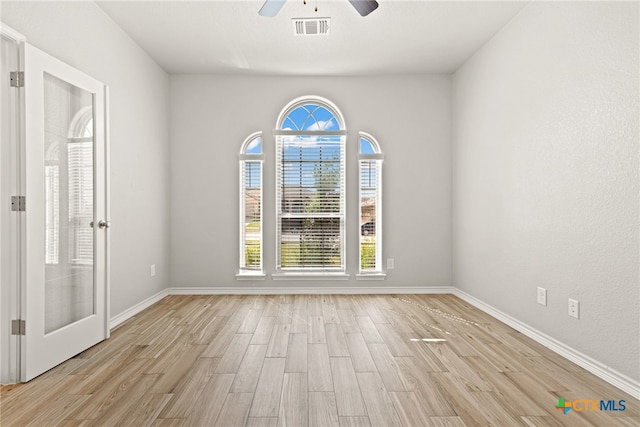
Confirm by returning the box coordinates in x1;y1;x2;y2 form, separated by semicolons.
356;132;386;280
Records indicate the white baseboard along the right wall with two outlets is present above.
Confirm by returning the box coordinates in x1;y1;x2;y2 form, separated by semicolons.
452;288;640;399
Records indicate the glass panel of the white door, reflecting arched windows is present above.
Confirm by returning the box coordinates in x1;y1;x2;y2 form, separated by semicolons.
44;73;95;334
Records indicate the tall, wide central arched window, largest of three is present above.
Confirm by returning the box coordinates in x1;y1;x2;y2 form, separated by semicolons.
275;96;346;273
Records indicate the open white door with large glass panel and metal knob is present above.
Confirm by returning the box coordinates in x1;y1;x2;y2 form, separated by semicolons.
21;44;109;381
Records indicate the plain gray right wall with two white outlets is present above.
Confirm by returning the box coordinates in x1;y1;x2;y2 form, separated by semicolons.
452;2;640;381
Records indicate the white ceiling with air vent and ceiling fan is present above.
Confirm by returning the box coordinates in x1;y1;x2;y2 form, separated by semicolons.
96;0;527;76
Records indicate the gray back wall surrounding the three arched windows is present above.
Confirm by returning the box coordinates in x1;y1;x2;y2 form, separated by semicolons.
170;75;451;288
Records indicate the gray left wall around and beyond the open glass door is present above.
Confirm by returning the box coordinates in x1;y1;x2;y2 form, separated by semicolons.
0;2;169;316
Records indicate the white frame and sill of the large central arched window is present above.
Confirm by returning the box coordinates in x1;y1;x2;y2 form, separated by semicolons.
272;95;349;280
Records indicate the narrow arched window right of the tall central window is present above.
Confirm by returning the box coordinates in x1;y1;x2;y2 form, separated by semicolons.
359;132;384;274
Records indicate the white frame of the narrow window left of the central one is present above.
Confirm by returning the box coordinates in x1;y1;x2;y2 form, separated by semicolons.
236;132;266;280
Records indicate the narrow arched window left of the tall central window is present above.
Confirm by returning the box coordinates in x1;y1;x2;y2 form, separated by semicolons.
238;132;264;277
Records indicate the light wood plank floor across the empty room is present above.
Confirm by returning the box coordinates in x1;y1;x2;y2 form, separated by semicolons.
0;295;640;427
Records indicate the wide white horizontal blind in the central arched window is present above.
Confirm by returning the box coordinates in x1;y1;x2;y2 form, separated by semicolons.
276;133;345;271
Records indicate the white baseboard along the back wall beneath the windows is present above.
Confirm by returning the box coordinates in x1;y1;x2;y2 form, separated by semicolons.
168;286;453;295
